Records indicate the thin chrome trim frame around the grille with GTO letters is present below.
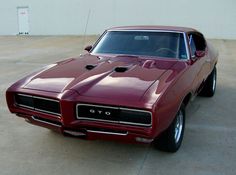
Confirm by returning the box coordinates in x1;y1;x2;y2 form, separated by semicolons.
76;103;152;127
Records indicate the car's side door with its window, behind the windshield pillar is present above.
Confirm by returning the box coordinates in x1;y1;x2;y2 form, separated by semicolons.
188;32;210;93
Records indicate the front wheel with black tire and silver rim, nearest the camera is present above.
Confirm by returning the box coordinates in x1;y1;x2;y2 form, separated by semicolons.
154;105;185;153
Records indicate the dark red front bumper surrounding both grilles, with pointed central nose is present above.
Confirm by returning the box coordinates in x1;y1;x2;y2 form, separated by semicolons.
7;91;156;143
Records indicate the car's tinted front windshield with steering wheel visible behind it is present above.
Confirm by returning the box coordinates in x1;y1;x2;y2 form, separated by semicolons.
92;31;187;59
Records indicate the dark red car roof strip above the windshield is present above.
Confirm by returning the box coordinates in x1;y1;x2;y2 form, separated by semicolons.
108;26;197;32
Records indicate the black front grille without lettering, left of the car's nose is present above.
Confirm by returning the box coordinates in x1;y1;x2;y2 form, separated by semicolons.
15;94;61;116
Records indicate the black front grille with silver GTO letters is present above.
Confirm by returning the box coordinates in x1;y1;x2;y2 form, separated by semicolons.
76;104;152;127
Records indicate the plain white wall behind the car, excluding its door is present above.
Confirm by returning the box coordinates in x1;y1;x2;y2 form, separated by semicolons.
0;0;236;39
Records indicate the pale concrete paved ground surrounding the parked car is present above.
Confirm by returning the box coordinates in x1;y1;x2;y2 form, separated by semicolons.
0;37;236;175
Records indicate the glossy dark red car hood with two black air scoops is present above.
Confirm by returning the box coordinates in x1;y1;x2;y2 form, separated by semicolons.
24;54;177;101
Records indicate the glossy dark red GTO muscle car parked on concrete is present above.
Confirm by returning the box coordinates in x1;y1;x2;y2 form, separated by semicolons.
6;26;218;152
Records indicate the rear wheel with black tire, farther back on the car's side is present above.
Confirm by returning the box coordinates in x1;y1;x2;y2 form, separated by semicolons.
199;67;217;97
